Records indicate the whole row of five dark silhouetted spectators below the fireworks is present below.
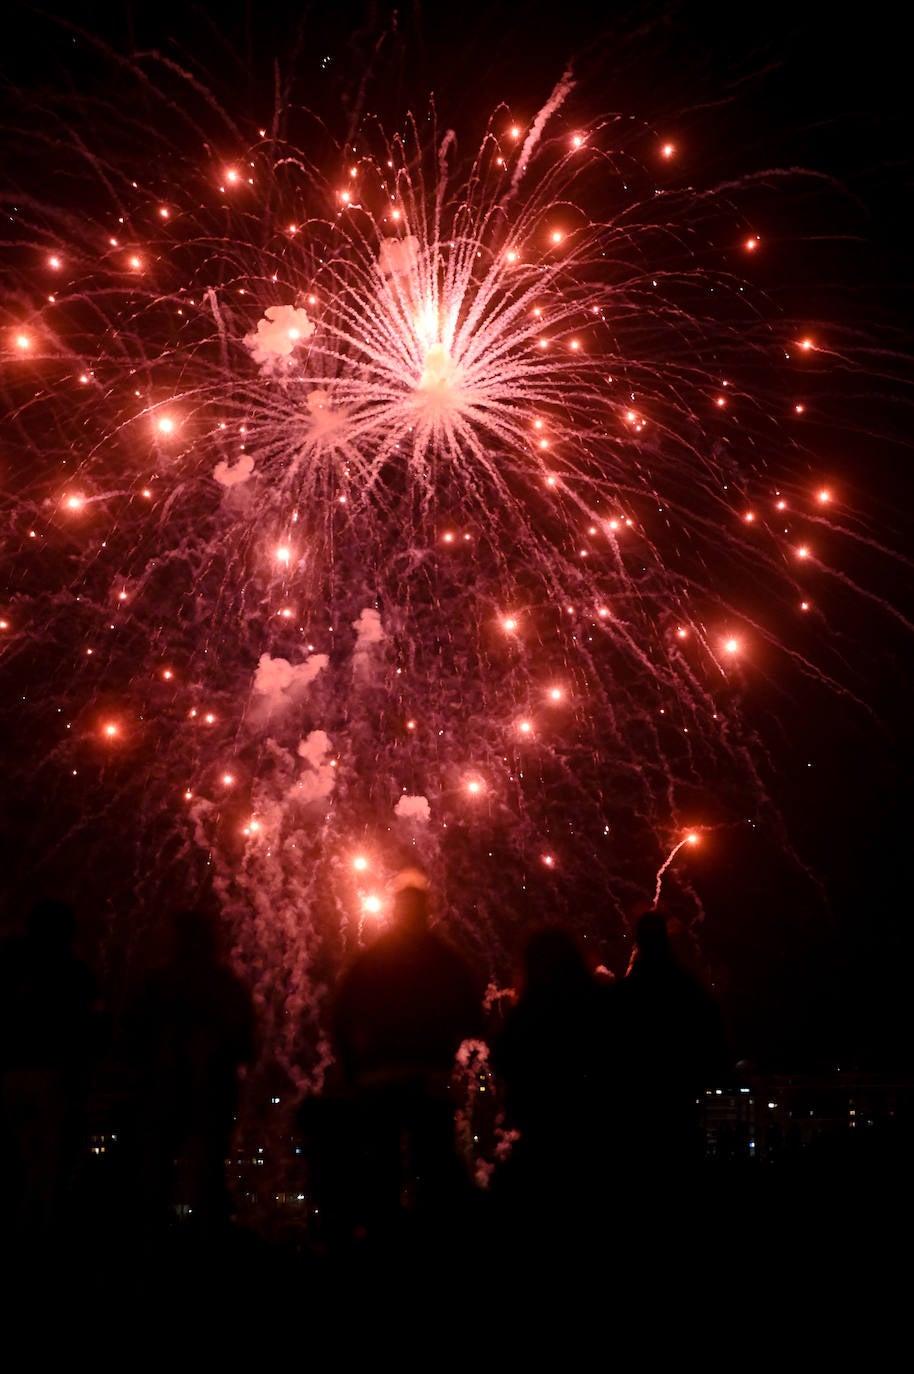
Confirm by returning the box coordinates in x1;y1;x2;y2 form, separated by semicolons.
0;870;896;1324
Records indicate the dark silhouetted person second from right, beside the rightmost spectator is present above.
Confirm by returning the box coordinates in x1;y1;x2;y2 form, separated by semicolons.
492;926;614;1219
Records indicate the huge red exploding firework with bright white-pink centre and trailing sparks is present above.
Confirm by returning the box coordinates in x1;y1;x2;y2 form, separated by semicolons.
0;32;901;1083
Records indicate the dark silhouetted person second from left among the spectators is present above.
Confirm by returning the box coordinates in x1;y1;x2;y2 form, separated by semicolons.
125;910;256;1228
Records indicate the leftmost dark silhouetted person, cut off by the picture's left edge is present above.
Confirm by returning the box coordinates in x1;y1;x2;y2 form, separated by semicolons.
0;899;100;1242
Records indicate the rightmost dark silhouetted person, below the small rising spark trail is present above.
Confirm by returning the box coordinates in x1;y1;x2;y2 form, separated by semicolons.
616;911;731;1184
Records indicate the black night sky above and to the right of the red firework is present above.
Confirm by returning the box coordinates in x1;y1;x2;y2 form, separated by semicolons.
0;0;914;1062
